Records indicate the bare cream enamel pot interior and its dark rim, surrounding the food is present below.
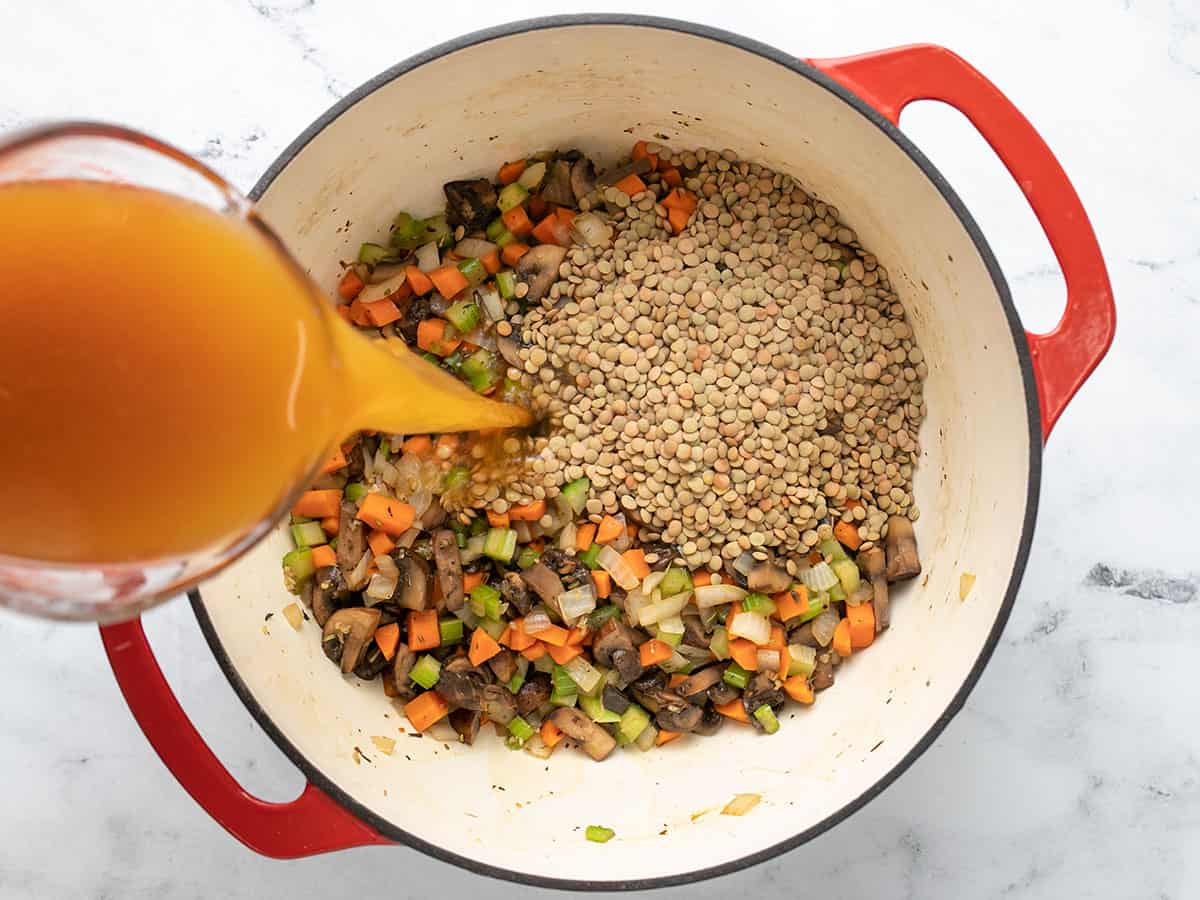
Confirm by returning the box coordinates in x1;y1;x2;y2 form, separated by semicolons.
189;19;1040;888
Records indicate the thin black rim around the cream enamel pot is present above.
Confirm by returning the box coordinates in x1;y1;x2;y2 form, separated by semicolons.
188;14;1042;890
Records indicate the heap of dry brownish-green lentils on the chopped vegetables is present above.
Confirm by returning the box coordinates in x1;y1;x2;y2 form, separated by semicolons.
491;148;928;571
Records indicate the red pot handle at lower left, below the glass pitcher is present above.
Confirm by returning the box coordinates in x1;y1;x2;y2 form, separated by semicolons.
100;619;390;859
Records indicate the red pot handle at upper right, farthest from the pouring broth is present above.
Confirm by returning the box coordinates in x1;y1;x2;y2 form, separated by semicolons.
809;44;1116;440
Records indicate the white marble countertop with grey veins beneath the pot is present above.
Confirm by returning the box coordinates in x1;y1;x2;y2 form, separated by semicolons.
0;0;1200;900
